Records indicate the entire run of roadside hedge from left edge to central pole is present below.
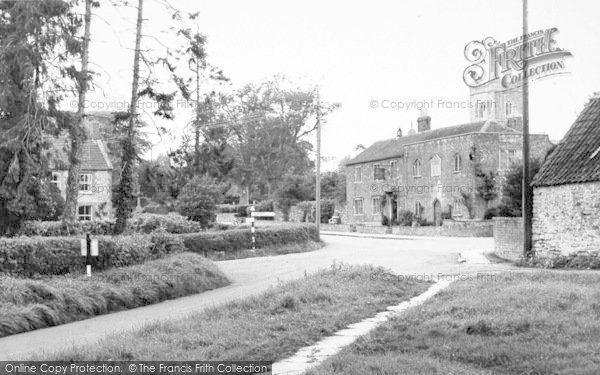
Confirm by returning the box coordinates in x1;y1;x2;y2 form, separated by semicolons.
0;224;318;277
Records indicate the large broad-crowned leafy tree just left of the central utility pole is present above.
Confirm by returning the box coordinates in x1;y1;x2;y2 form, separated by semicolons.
218;77;339;201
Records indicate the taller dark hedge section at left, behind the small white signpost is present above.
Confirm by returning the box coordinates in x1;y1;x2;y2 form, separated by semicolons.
0;231;185;277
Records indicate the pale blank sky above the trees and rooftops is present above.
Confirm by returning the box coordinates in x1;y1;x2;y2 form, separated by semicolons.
83;0;600;170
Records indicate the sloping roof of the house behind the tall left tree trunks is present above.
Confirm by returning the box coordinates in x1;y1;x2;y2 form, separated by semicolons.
49;136;113;171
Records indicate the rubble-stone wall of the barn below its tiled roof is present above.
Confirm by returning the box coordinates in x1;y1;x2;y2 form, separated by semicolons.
533;182;600;257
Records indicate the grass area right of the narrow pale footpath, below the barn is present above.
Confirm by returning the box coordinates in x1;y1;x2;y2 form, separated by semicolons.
309;271;600;375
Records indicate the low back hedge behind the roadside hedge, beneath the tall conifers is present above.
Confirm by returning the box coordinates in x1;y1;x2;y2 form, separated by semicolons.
17;213;202;237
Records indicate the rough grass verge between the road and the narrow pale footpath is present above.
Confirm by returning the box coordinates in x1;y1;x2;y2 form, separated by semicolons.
40;266;429;361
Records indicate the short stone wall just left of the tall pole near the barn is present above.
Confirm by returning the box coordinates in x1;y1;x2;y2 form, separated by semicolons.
493;217;523;261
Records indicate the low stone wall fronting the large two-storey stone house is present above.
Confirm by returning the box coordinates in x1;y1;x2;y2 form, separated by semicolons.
321;220;492;237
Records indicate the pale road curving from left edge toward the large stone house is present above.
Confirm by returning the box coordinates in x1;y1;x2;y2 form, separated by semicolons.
0;235;509;360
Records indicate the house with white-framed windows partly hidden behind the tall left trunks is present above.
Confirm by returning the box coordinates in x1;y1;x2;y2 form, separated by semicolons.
50;116;113;220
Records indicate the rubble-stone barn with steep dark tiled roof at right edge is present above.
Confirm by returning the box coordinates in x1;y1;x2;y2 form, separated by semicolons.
532;93;600;257
